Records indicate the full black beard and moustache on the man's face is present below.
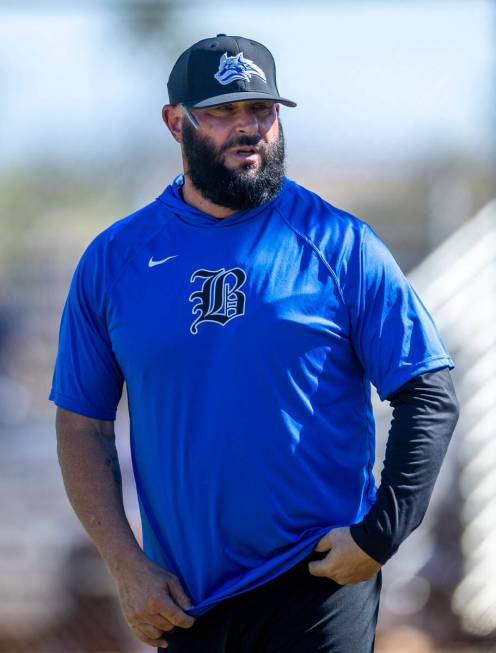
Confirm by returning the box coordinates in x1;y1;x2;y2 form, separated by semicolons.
183;118;285;211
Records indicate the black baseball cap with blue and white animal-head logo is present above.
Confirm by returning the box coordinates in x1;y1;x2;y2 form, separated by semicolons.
167;34;296;109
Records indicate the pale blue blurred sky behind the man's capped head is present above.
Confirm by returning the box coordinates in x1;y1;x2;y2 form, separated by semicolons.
0;0;496;166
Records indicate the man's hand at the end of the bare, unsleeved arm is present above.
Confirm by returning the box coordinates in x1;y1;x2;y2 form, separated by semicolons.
114;557;195;648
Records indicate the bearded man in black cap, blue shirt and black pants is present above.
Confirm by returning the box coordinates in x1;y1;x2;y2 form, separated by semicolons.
51;34;457;653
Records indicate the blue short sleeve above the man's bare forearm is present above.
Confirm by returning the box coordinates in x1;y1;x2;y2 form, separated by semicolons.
49;243;123;420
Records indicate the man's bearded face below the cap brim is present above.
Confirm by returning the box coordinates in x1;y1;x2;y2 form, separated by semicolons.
182;100;285;211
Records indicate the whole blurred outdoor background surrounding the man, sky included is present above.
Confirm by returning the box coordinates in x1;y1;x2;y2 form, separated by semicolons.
0;0;496;653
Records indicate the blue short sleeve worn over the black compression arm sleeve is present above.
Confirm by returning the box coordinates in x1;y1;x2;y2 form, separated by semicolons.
351;225;454;400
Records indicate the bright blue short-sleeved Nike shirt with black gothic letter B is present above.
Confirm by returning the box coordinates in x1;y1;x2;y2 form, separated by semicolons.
50;176;453;616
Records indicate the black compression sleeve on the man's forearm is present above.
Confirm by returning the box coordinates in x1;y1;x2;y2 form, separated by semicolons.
350;368;458;564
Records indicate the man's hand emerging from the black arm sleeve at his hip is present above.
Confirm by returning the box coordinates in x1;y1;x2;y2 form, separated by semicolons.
308;527;381;585
